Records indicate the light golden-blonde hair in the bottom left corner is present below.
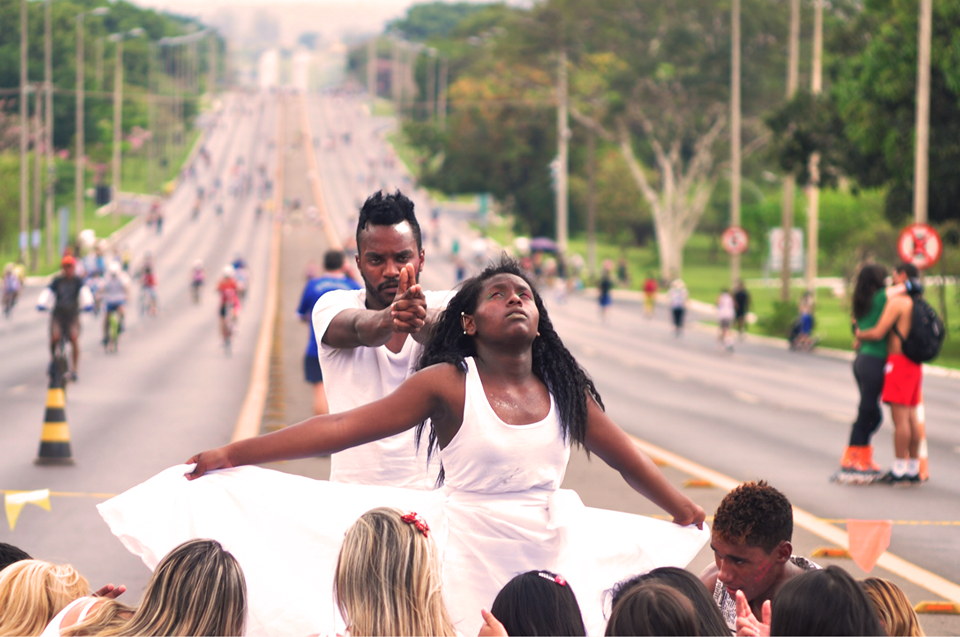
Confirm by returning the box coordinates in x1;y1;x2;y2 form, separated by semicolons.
0;560;90;635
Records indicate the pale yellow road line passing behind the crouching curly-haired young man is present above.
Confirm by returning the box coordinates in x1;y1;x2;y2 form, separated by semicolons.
630;436;960;603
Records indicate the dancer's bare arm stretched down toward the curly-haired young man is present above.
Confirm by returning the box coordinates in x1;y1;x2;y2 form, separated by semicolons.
584;398;706;528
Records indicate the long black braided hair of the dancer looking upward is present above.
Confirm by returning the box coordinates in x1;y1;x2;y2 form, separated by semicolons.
416;254;603;468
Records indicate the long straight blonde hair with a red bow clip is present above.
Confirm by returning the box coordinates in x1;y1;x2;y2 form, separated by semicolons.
333;508;456;637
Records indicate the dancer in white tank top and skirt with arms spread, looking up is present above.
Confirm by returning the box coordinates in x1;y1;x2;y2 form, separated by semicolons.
100;259;708;634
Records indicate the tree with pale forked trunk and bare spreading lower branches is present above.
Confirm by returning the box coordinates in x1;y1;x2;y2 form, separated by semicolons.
571;0;786;278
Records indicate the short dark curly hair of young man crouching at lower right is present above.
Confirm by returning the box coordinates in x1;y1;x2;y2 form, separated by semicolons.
713;480;793;553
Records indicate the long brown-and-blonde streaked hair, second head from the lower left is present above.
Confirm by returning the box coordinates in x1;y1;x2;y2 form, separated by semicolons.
75;540;247;637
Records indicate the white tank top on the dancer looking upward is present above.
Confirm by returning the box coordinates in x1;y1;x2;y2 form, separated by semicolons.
440;357;570;493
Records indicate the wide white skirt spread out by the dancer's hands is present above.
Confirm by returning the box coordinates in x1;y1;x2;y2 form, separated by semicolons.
97;465;709;636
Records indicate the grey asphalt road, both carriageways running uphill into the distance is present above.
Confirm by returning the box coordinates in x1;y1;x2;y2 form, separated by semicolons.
0;89;960;633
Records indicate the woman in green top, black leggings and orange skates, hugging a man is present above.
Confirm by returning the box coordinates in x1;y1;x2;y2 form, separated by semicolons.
834;264;887;484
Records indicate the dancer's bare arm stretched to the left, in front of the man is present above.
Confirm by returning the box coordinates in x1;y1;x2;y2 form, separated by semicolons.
187;364;462;480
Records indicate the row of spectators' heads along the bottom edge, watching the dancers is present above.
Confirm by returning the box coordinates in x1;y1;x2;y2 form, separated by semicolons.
0;482;923;636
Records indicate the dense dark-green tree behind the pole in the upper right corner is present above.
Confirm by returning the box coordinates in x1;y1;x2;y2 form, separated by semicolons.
768;0;960;225
